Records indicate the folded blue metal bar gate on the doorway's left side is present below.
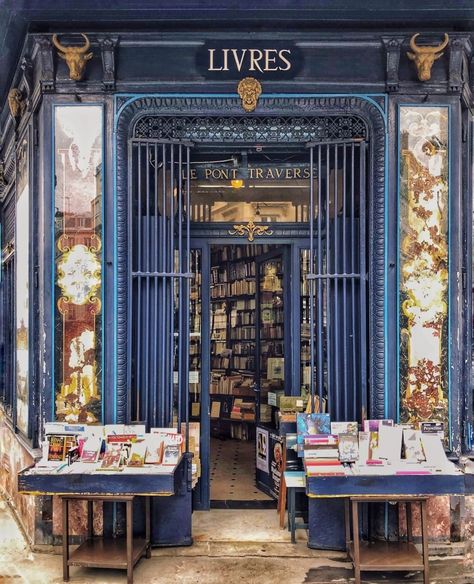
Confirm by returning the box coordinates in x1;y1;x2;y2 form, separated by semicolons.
129;140;191;438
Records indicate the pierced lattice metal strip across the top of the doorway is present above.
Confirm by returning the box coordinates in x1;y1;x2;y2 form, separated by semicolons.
133;115;368;143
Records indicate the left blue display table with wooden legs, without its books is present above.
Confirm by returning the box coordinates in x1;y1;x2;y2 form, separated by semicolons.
18;455;192;583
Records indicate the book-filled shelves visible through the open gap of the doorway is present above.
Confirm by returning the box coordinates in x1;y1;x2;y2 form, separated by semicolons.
210;245;268;440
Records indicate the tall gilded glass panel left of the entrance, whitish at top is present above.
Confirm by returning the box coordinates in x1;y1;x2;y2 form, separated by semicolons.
54;105;103;423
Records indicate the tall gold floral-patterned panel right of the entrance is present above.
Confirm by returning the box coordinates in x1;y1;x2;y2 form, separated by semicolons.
400;106;449;423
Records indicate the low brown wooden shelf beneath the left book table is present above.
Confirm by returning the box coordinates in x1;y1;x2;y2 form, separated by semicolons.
68;537;147;569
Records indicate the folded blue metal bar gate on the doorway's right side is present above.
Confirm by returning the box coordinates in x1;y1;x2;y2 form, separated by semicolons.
307;141;367;421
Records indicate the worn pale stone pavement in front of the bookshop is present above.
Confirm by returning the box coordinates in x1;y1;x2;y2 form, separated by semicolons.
0;499;474;584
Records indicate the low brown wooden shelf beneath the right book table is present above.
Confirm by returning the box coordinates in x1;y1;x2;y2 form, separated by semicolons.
349;541;423;571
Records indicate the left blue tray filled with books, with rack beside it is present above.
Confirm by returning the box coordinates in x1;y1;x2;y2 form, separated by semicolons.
18;422;201;495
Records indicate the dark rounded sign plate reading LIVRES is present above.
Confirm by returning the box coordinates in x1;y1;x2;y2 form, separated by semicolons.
196;41;303;80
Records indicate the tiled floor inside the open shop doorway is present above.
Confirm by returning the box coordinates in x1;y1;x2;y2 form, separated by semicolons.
211;438;272;501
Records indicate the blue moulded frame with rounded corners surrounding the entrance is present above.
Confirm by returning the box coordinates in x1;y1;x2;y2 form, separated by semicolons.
115;96;386;422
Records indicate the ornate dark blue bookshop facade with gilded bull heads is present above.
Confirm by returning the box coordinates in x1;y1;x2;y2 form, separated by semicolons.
0;3;474;547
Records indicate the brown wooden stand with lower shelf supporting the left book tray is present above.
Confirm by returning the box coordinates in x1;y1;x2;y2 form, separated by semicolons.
61;495;151;584
